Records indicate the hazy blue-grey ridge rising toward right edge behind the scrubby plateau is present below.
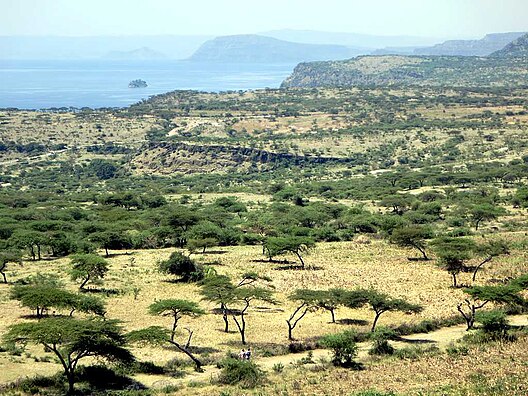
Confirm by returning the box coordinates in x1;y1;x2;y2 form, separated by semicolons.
414;32;524;56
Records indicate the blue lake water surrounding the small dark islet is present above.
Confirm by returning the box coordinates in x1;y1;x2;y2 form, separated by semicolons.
0;60;295;109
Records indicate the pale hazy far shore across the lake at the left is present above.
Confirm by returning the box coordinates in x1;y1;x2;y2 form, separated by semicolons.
0;36;212;60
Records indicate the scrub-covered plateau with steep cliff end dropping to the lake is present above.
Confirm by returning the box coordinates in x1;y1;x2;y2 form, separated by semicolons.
281;56;528;88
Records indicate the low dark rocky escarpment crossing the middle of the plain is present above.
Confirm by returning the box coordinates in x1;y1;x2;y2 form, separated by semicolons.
130;142;365;174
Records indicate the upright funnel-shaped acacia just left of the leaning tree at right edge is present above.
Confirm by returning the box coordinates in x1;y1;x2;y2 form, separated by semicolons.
434;237;476;287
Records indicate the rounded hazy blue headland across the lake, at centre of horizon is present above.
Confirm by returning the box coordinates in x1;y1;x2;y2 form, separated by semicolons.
190;34;366;63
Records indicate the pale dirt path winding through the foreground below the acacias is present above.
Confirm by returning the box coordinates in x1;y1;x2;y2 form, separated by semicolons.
135;315;528;388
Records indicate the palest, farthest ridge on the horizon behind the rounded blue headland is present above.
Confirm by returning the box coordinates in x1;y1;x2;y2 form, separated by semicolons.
260;29;440;48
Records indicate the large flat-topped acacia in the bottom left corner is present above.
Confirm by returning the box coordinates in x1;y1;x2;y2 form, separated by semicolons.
4;318;134;394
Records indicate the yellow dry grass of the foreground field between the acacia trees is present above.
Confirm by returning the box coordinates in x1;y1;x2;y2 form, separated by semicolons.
0;240;528;383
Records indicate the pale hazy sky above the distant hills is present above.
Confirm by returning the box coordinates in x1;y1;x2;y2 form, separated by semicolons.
0;0;528;37
